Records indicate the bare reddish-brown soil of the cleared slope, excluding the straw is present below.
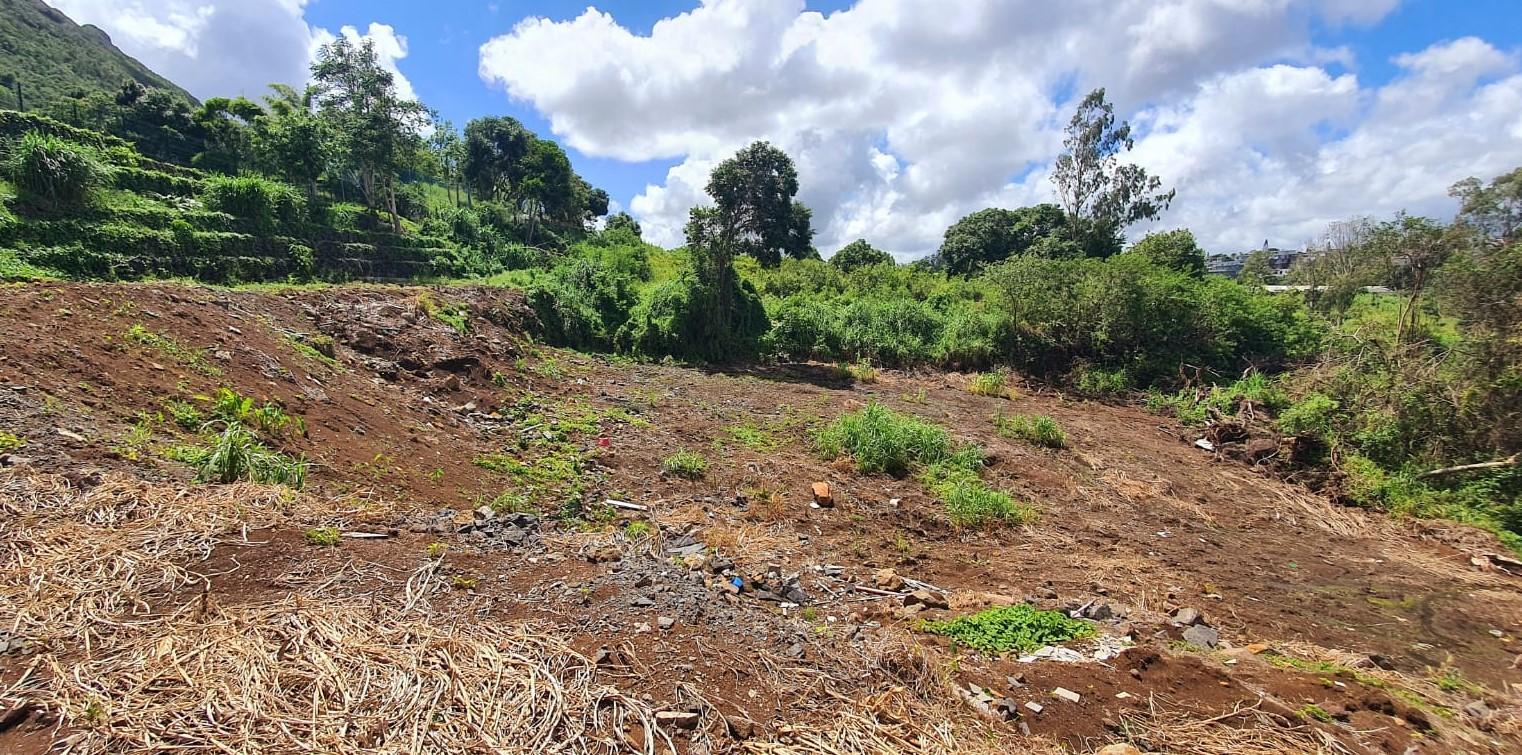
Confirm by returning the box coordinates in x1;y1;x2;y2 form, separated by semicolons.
0;285;1522;753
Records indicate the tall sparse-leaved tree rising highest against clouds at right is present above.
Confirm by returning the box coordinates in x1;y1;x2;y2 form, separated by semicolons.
1052;88;1173;257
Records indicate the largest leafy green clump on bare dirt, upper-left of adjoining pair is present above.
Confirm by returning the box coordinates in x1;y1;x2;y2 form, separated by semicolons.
814;402;951;476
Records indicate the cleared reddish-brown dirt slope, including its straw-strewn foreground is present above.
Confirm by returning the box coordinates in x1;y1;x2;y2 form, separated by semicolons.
0;285;1522;752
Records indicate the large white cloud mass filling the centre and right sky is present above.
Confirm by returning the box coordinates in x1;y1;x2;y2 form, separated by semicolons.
479;0;1522;259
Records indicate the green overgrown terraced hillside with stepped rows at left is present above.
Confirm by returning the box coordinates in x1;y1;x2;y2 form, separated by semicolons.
0;110;487;282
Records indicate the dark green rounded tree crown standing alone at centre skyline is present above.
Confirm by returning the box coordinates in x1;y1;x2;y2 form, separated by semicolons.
694;142;817;266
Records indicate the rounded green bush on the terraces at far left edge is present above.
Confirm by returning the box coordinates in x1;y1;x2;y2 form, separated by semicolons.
6;131;111;209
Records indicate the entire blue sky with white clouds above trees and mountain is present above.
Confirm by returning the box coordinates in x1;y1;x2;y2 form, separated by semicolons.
41;0;1522;259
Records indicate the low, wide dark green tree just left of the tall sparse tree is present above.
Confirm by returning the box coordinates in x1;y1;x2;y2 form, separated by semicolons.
938;204;1078;276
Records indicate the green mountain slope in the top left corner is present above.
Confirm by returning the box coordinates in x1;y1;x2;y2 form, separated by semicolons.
0;0;195;113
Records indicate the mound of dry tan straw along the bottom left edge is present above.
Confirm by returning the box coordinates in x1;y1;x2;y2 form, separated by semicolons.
23;598;670;753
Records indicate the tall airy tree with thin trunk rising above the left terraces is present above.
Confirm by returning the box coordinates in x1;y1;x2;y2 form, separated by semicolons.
312;37;428;233
